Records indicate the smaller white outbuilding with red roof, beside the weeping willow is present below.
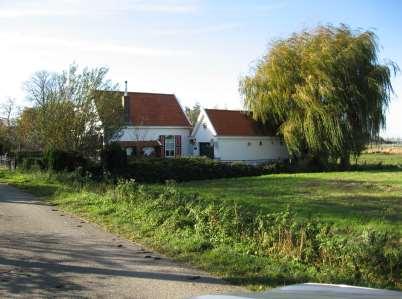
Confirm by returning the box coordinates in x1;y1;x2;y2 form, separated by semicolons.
190;109;288;164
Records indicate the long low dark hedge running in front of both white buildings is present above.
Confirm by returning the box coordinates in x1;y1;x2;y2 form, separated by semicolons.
16;143;288;183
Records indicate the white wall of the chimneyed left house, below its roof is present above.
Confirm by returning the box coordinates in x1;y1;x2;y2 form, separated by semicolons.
117;126;192;156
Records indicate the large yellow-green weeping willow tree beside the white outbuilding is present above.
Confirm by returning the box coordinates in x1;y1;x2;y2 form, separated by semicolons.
240;25;398;168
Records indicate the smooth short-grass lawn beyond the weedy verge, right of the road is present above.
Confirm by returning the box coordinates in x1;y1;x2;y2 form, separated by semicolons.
175;172;402;231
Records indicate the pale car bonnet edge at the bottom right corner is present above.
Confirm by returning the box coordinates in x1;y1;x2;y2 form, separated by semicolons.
193;283;402;299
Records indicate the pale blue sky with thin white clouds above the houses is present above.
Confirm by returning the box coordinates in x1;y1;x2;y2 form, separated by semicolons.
0;0;402;137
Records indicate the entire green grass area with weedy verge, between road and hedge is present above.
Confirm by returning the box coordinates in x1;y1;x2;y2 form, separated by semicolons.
0;154;402;289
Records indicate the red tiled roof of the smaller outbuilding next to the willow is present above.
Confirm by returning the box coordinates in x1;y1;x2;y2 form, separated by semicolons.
205;109;274;136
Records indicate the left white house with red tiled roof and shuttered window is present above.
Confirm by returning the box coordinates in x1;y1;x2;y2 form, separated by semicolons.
114;91;191;158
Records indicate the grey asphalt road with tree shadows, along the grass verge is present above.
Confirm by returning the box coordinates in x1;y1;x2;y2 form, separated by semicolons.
0;184;239;298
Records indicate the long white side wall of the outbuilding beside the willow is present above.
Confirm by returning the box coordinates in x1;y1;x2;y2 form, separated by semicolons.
215;137;289;162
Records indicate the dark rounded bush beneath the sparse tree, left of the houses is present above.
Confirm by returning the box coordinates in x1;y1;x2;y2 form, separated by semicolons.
44;149;87;171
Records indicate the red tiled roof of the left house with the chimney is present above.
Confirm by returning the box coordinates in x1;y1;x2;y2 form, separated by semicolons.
121;92;191;127
